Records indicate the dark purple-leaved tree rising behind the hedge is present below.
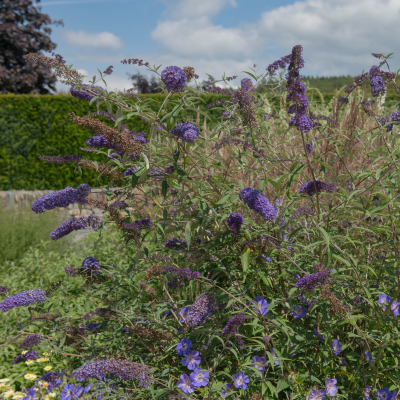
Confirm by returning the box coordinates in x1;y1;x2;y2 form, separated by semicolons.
0;0;64;94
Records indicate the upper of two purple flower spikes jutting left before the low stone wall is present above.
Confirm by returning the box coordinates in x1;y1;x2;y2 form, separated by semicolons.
31;183;91;214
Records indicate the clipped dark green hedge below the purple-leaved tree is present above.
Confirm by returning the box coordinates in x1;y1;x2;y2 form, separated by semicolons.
0;93;231;190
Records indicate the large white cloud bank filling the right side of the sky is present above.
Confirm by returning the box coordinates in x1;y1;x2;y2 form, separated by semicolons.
151;0;400;75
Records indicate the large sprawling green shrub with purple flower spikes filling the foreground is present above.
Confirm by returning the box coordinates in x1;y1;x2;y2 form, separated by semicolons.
0;46;400;400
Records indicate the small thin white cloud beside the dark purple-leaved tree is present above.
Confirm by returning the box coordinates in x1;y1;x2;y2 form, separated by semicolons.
63;30;123;49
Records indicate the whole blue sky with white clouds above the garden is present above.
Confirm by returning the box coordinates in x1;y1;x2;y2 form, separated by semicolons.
34;0;400;91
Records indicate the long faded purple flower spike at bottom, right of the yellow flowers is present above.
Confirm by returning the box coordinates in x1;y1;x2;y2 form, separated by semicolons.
74;358;153;387
